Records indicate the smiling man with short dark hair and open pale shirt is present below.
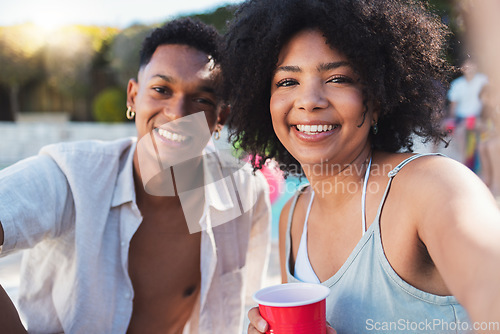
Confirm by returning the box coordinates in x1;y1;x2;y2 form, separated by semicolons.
0;19;270;333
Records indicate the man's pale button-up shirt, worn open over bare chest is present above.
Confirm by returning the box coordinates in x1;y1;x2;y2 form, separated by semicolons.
0;138;271;334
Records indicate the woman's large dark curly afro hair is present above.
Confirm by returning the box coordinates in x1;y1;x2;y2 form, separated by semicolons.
222;0;452;172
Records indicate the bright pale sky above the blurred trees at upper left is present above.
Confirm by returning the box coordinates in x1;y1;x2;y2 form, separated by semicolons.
0;0;242;28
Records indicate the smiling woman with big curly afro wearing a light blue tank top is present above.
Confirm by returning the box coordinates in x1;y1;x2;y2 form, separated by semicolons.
223;0;500;333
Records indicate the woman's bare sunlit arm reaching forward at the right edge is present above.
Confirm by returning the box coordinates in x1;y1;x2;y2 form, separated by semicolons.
409;158;500;333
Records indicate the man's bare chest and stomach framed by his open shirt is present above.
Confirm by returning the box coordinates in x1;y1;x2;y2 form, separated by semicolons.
128;210;201;328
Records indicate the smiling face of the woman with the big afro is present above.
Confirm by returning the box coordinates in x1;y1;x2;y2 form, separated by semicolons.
270;30;376;171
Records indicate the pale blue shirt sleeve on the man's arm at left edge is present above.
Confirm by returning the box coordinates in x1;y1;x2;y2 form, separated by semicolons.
0;155;74;254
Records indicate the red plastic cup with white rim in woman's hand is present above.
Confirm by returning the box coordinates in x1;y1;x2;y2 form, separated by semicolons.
253;283;330;334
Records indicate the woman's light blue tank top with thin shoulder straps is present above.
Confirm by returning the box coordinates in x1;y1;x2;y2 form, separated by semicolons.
286;154;472;334
